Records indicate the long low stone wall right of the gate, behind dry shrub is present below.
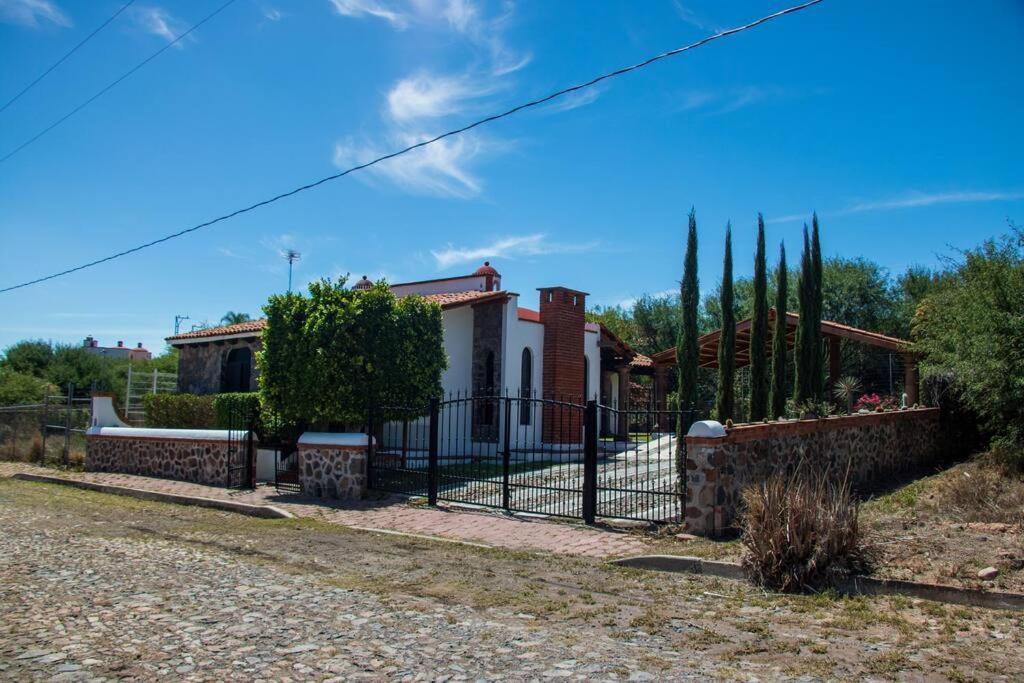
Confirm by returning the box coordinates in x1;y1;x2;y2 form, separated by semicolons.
685;409;944;536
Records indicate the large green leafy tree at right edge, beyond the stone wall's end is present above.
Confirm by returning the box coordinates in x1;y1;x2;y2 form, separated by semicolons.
913;224;1024;458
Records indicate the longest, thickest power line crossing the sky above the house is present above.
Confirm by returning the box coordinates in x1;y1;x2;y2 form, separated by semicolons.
0;0;822;294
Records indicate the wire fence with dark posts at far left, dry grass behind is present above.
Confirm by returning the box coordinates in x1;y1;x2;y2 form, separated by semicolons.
0;384;91;468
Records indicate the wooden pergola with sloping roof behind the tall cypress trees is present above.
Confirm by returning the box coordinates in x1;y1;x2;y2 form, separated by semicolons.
651;308;919;404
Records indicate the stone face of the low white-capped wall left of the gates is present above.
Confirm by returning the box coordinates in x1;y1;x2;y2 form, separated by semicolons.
85;435;227;486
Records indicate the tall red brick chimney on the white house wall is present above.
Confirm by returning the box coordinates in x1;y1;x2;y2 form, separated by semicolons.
540;287;587;443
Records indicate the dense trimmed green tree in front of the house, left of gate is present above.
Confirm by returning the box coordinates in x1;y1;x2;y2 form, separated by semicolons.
256;278;447;428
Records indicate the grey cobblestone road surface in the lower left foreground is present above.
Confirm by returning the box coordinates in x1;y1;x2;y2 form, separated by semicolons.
0;499;692;681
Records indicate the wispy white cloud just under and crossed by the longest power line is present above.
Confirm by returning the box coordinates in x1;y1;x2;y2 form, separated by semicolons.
334;132;483;199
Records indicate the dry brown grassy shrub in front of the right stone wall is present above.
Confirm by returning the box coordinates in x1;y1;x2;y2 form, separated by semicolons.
740;467;873;592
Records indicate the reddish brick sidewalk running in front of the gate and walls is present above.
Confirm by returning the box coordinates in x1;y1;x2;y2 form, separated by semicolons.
0;463;646;558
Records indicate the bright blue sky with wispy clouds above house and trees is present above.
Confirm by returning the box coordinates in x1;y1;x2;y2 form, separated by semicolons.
0;0;1024;349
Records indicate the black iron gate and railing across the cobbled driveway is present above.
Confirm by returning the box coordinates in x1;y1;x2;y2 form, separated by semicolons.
369;394;695;523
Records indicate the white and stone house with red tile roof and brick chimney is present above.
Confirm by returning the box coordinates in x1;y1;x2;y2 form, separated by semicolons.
167;263;657;429
